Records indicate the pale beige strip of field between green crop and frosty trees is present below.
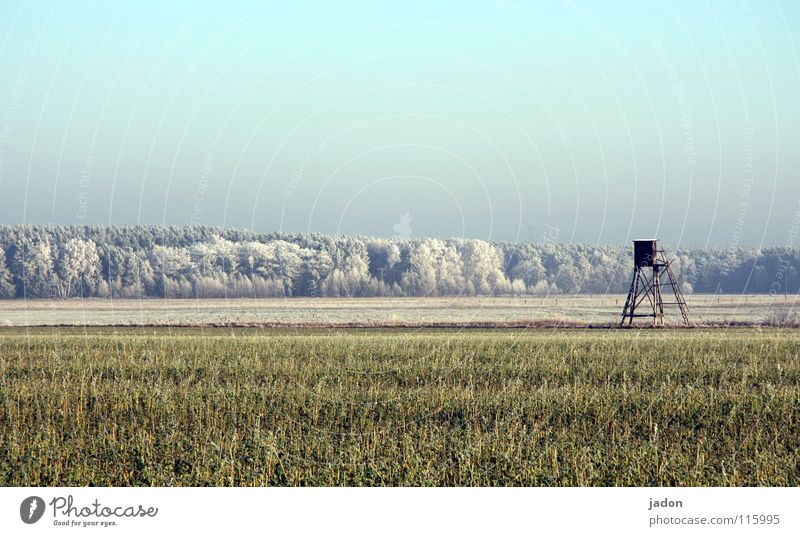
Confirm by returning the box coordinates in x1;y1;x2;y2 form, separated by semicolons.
0;295;800;327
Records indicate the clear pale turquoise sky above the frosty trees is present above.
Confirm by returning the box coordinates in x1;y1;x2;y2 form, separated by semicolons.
0;0;800;246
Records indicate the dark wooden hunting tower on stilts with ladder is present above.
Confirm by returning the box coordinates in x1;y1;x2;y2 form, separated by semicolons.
620;238;689;326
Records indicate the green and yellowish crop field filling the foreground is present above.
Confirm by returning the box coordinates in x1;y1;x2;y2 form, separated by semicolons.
0;328;800;486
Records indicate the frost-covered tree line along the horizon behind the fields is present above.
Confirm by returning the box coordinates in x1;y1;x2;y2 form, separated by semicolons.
0;225;800;298
